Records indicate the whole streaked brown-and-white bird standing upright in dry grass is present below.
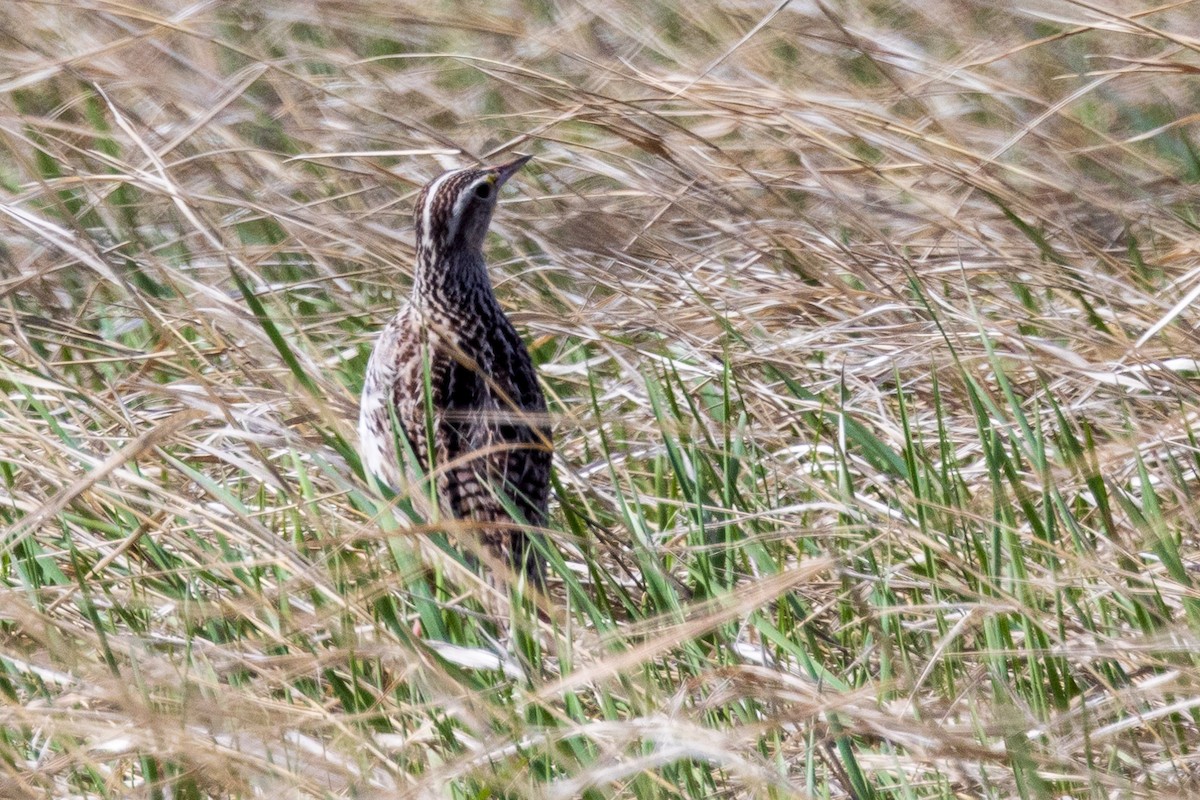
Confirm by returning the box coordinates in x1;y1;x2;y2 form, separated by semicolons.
359;156;553;587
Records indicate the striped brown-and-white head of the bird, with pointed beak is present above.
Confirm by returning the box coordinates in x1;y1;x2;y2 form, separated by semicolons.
415;156;530;259
